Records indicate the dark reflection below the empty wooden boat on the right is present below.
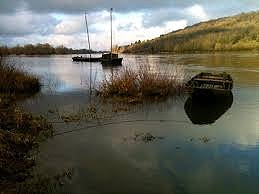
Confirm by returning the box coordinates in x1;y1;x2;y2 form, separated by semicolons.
184;92;233;125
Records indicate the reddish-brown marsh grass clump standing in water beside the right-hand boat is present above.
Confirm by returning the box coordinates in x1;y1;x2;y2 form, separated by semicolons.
98;66;187;103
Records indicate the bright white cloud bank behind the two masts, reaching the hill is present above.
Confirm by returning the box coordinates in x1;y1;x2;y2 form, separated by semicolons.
38;12;187;50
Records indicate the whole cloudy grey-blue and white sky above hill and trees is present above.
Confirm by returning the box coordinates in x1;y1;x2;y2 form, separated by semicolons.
0;0;259;50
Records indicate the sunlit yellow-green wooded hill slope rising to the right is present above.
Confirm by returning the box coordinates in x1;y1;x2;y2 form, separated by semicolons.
119;11;259;53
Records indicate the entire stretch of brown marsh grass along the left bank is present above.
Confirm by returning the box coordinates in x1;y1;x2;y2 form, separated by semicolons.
0;53;66;193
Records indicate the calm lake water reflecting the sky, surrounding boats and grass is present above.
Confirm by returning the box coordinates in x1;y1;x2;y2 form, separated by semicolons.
15;52;259;193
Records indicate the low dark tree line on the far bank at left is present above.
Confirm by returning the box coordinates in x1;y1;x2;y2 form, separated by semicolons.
0;43;100;55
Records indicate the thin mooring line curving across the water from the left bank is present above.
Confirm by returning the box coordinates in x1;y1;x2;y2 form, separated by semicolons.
53;119;191;136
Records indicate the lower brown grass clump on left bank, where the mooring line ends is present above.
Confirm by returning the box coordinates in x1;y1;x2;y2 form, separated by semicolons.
0;97;53;193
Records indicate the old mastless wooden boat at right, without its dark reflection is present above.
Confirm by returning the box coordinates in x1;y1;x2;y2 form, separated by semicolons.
185;72;233;94
